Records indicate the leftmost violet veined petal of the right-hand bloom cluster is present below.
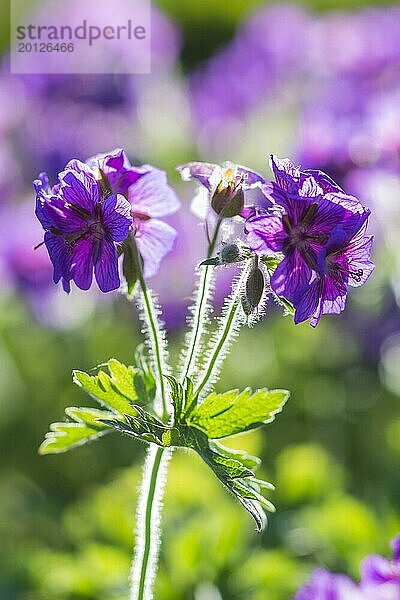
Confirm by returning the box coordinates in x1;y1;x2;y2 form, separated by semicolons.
245;215;288;252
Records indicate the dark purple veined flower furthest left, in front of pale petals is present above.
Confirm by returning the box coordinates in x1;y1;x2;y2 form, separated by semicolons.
34;160;132;292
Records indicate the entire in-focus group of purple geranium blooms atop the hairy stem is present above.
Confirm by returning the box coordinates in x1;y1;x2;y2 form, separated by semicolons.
34;150;374;326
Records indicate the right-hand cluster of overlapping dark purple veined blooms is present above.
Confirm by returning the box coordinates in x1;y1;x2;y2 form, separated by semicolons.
245;156;374;326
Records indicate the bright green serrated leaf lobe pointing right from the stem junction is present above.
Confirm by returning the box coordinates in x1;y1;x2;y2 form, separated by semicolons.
188;388;289;439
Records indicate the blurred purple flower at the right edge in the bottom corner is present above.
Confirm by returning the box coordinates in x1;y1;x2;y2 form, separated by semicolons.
361;536;400;600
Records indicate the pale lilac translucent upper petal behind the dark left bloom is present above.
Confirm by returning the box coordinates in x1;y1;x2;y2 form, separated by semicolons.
128;166;180;217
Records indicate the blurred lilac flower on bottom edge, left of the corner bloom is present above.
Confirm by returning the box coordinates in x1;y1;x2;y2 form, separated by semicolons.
293;569;363;600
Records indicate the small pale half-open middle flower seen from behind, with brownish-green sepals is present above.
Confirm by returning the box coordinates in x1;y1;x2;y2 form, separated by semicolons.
177;162;267;221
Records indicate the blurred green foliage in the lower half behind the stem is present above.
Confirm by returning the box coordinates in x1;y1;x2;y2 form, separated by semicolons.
0;288;400;600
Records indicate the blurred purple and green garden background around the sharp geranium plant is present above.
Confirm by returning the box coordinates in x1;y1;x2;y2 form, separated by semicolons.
0;0;400;600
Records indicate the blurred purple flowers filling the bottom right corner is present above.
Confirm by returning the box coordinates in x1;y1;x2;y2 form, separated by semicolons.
294;536;400;600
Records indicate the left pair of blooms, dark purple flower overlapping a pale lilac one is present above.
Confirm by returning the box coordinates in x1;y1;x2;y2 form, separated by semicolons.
34;150;179;292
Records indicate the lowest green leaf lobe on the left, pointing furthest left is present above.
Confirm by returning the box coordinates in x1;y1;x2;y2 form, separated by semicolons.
39;407;113;454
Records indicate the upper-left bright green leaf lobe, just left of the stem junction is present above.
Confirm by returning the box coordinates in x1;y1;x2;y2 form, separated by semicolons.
74;358;152;415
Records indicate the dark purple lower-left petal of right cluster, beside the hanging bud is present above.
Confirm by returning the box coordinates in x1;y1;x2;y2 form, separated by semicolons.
271;248;313;302
